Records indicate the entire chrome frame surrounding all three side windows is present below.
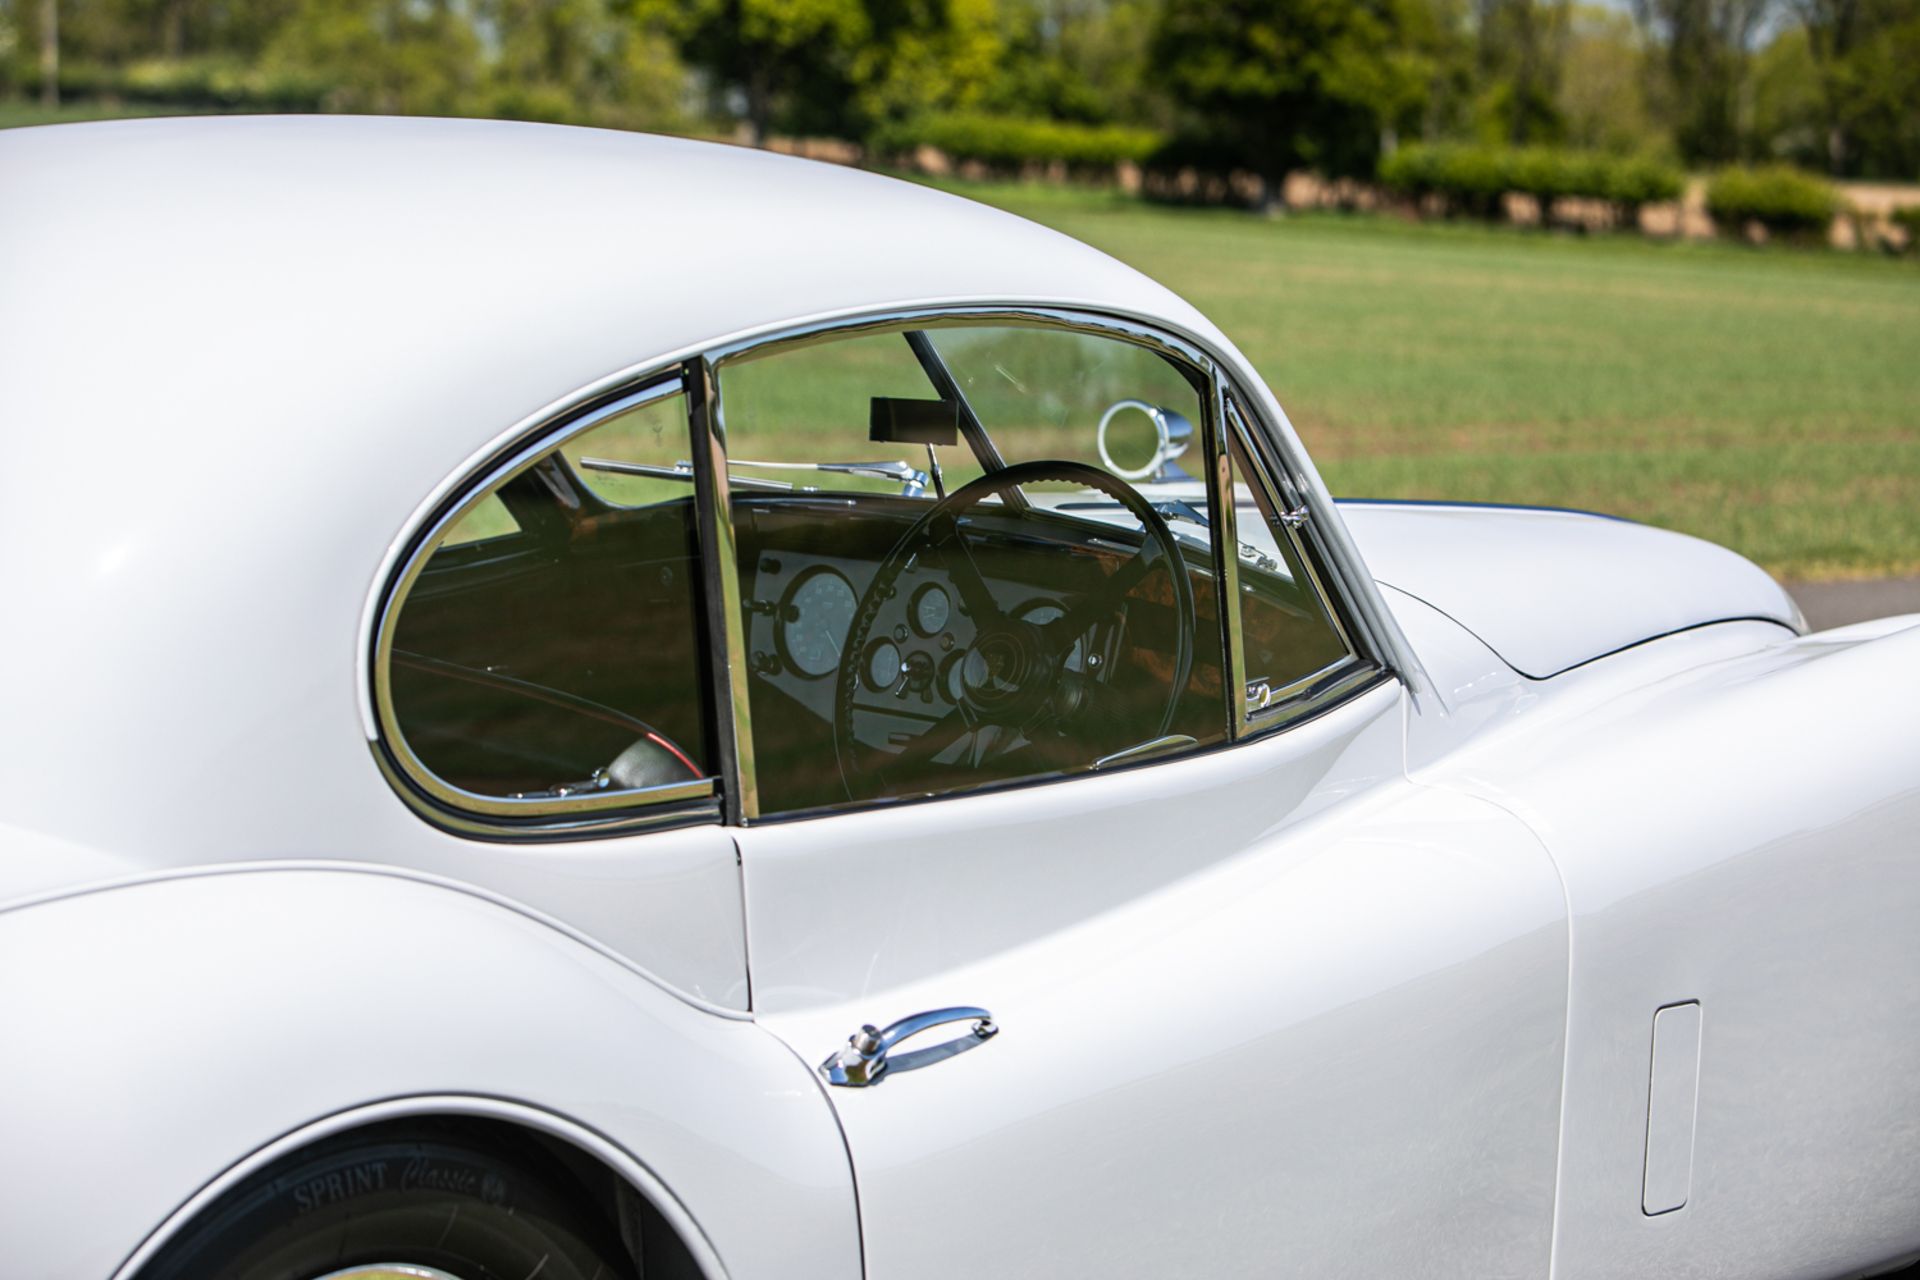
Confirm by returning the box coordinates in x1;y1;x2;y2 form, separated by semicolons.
367;303;1396;841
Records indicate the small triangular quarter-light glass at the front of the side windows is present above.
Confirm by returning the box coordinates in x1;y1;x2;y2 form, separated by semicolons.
1229;407;1354;723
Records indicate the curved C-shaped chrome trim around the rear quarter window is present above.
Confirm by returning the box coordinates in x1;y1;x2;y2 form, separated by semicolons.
371;367;718;839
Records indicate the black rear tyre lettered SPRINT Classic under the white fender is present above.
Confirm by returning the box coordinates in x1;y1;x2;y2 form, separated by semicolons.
140;1132;636;1280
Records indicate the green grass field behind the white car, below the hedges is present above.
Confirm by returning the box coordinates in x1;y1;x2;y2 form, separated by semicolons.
913;184;1920;580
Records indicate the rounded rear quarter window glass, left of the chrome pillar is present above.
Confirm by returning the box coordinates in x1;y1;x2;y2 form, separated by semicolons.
384;382;714;812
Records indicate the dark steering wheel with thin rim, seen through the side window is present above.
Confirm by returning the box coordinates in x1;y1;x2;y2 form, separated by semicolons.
833;459;1194;800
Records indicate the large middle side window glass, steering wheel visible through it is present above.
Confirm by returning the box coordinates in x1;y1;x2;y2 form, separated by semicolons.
718;326;1227;814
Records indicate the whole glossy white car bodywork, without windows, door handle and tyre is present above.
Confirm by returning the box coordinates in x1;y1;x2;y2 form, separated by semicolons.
0;119;1920;1280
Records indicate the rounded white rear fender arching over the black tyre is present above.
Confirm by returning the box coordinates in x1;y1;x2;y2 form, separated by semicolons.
0;869;860;1280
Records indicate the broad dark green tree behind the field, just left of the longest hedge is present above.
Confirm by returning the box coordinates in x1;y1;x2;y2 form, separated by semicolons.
1152;0;1430;207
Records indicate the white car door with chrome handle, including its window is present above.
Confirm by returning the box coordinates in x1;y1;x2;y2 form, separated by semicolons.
705;317;1567;1278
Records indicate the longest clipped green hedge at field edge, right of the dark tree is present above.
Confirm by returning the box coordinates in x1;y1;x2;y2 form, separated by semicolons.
1379;142;1686;225
